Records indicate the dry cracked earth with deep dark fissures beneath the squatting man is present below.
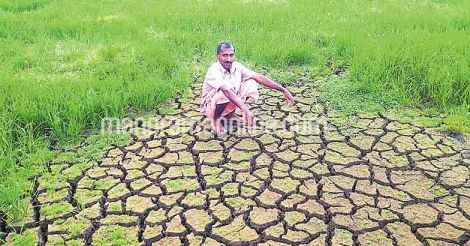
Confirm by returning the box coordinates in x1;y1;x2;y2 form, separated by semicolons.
1;79;470;245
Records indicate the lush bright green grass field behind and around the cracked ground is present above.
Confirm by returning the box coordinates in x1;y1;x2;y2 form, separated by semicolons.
0;0;470;219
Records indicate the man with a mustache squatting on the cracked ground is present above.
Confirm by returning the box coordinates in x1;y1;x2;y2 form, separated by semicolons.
201;41;294;134
